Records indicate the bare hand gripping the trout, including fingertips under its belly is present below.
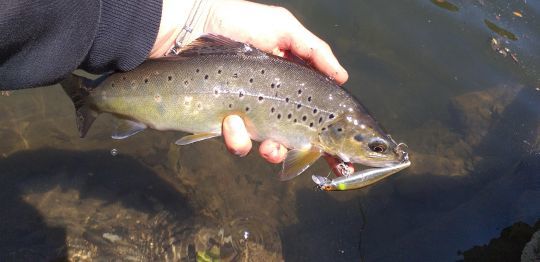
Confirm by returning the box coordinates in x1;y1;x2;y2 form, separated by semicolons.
150;0;348;163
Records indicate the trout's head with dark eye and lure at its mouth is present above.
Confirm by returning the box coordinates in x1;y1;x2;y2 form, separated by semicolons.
319;113;408;167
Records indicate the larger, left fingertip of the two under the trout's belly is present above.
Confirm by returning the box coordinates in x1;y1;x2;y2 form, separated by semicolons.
222;115;251;156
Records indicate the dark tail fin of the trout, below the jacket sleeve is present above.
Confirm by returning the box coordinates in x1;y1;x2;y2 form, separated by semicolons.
60;74;99;138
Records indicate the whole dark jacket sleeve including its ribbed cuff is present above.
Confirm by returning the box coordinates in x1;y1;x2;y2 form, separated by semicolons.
0;0;162;90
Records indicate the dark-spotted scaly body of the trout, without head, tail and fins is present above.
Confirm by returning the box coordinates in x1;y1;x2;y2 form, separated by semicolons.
98;54;355;148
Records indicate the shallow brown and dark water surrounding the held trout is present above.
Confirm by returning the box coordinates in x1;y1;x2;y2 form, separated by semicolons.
0;0;540;261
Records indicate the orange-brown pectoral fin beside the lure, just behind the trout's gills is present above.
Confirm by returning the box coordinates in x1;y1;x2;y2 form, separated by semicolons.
279;147;322;181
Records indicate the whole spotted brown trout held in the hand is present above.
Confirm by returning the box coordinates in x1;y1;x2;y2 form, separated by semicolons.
62;35;407;186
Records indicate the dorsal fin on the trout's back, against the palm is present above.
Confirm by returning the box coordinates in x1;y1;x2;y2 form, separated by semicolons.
173;34;267;57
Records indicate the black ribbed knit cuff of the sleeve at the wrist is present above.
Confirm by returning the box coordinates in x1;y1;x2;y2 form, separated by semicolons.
80;0;162;73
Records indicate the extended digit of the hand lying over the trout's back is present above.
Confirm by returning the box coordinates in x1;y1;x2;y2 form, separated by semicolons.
288;25;349;84
